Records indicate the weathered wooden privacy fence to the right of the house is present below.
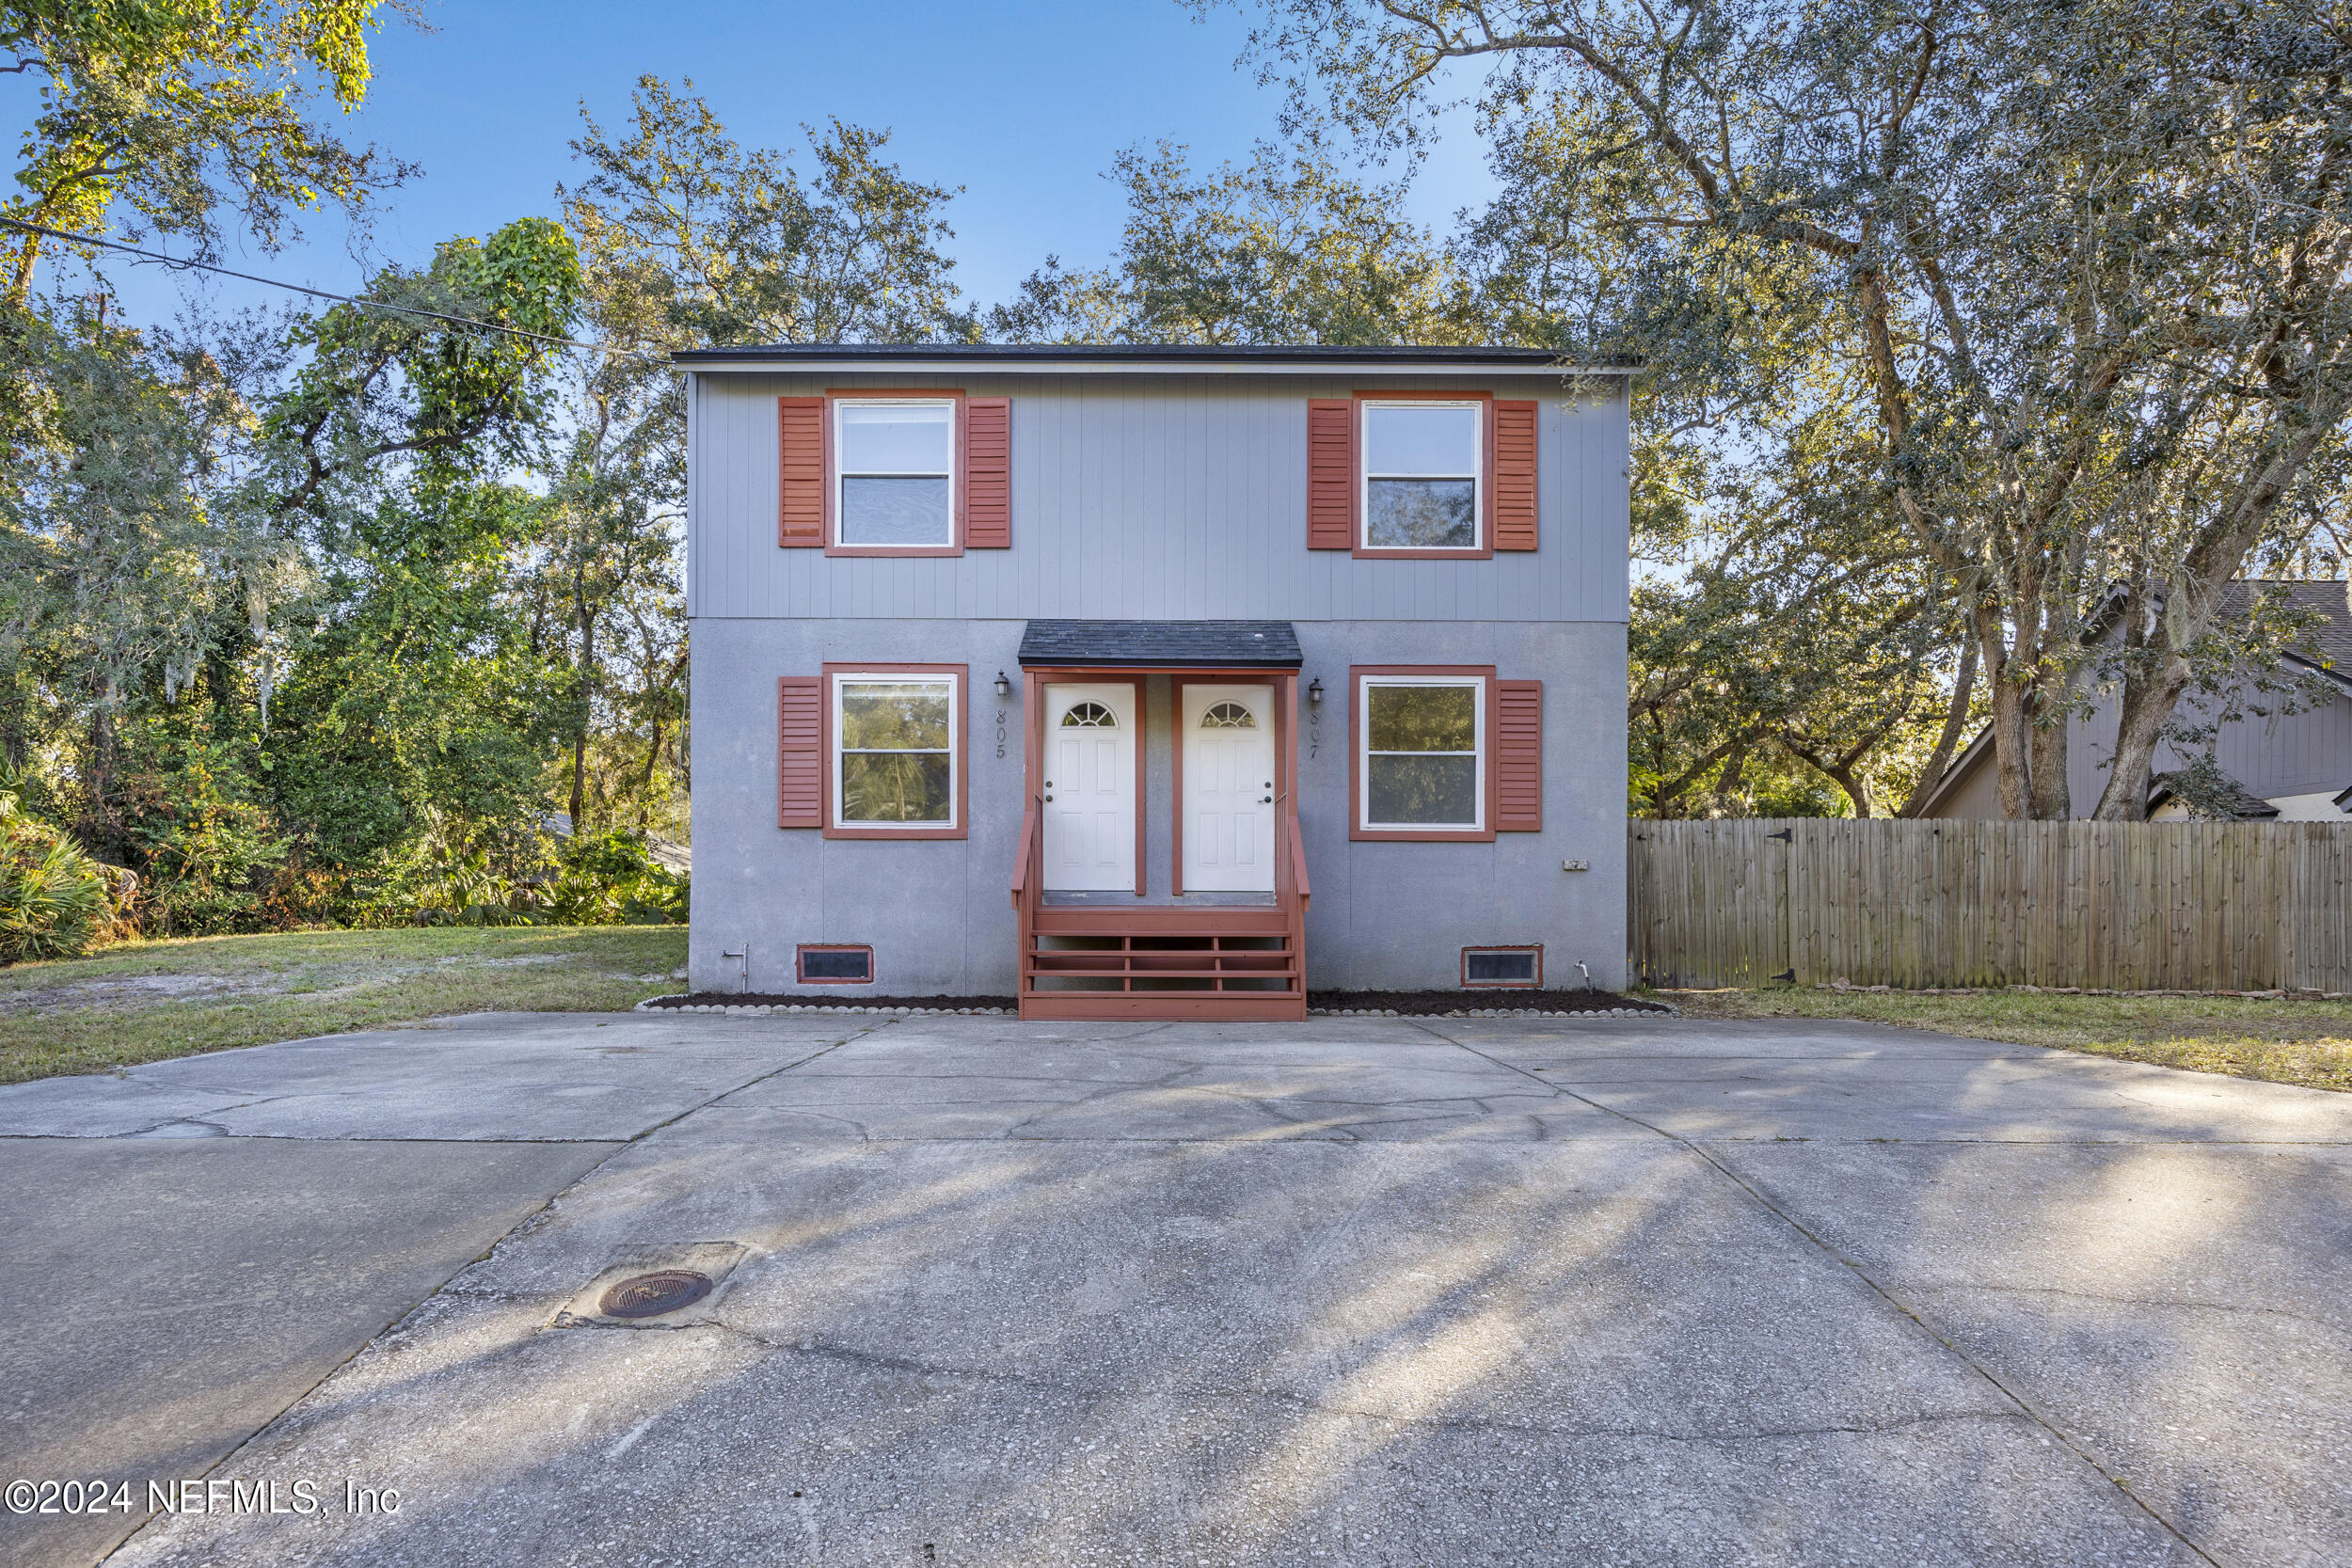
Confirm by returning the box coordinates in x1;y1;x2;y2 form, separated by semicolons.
1626;818;2352;992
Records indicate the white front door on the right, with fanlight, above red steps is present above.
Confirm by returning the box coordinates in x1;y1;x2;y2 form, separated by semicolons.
1176;687;1275;894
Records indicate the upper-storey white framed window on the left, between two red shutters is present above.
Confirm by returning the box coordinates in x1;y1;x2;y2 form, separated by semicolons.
833;397;955;550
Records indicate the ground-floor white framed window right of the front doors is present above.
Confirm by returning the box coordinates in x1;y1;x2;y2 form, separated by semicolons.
1355;674;1486;834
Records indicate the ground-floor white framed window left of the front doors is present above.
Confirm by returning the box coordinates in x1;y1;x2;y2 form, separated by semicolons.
831;670;964;832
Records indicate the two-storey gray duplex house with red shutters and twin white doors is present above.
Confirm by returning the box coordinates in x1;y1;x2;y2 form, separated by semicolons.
680;345;1628;1018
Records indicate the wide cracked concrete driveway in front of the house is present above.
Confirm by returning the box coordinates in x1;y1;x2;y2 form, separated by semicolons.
0;1016;2352;1568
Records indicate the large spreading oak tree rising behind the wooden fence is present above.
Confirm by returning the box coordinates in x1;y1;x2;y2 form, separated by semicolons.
1256;0;2352;818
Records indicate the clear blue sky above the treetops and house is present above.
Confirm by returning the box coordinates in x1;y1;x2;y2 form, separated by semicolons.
41;0;1489;331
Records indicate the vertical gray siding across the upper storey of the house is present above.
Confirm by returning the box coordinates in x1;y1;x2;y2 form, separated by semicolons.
687;373;1628;621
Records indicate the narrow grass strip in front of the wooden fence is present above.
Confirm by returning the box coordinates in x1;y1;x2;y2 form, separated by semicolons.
1645;988;2352;1091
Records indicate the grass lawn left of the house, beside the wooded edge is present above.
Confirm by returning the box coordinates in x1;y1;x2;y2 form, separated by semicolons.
0;927;687;1084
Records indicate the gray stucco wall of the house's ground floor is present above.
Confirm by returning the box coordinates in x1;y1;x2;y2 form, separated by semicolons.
690;618;1626;997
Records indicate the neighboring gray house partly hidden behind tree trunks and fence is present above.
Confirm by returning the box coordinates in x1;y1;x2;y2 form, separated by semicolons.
1919;583;2352;823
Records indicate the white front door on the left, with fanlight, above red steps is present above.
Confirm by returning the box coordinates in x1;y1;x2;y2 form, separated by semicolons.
1042;687;1136;894
